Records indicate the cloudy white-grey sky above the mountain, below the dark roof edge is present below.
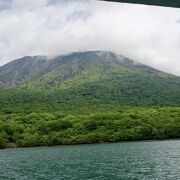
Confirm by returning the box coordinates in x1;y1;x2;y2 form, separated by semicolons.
0;0;180;75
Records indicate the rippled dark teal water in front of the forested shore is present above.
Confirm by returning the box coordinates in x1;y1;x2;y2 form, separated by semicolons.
0;140;180;180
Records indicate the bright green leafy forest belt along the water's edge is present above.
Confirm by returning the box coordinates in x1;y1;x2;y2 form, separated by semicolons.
0;93;180;148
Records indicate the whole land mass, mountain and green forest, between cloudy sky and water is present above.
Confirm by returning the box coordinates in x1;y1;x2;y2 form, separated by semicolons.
0;51;180;147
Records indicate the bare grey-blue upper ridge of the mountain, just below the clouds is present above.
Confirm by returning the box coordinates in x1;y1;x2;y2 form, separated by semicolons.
0;51;172;88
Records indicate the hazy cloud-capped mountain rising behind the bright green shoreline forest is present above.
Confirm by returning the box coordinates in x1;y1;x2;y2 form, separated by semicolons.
0;51;180;106
